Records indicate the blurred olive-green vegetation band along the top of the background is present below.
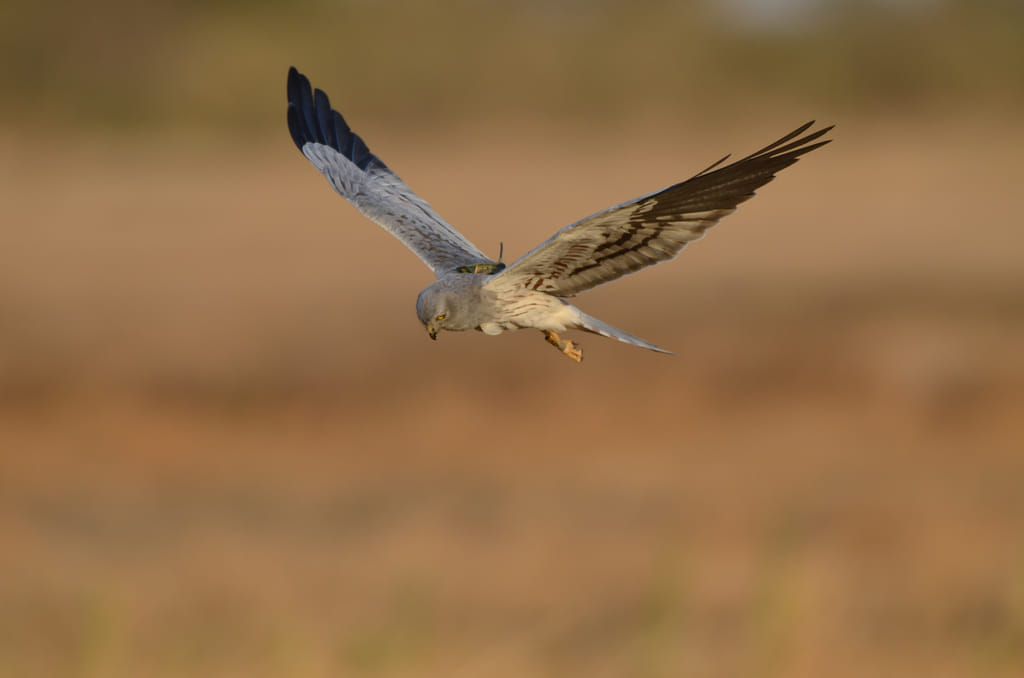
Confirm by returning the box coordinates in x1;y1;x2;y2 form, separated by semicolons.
0;0;1024;130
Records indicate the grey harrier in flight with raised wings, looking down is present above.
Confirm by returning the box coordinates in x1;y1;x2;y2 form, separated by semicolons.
288;67;834;363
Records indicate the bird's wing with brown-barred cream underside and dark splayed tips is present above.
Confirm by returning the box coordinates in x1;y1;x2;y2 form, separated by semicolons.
487;122;831;297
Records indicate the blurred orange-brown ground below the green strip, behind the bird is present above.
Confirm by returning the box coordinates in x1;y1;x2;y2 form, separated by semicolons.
0;114;1024;676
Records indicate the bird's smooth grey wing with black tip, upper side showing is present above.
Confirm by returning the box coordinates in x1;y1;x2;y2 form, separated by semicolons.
288;67;494;277
